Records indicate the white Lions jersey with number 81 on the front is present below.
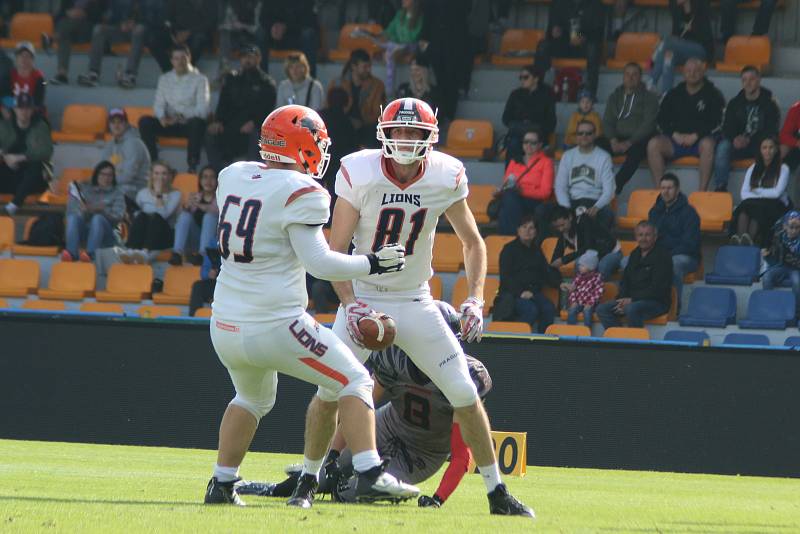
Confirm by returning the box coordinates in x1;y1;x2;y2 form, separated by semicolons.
336;150;468;291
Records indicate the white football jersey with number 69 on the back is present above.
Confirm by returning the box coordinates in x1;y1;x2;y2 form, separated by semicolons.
212;162;330;322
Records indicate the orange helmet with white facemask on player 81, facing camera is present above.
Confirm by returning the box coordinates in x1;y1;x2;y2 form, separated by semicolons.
378;98;439;165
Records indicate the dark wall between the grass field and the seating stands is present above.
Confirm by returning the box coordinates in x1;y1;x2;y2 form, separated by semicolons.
0;314;800;477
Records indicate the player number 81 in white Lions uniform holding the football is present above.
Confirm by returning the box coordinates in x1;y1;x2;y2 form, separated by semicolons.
294;98;533;517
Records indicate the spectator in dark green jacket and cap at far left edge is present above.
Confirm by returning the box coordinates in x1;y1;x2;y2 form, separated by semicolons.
0;93;53;215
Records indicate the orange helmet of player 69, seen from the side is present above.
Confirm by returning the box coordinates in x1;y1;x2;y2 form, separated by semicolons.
258;105;331;180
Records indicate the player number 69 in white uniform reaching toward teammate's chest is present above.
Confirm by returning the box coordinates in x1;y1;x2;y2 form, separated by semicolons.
205;106;419;508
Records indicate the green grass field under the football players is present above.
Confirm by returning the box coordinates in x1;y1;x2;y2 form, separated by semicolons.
0;440;800;534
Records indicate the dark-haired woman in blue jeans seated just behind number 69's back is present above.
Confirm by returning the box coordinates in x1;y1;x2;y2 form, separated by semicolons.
169;165;219;265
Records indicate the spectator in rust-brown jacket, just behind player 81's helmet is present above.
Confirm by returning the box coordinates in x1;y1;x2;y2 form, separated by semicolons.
328;48;386;147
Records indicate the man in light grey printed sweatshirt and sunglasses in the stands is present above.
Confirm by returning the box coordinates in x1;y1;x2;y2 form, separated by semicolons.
555;121;614;228
